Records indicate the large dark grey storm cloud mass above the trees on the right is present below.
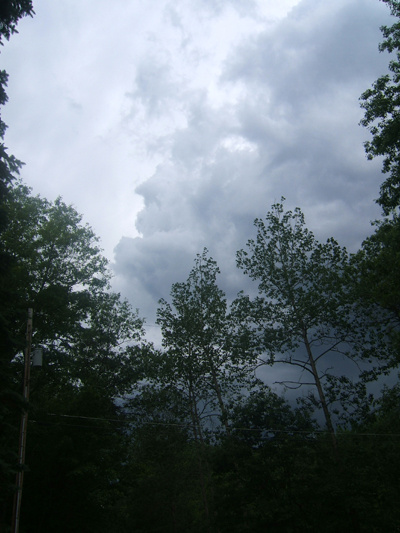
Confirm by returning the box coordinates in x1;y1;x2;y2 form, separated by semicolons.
115;0;394;342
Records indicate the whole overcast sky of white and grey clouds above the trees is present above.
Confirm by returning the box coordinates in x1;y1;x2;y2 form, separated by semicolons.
0;0;390;342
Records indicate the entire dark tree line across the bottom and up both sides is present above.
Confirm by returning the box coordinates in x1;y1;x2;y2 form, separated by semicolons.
0;0;400;533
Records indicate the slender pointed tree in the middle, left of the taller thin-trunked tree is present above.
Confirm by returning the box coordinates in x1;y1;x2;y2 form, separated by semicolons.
157;249;253;437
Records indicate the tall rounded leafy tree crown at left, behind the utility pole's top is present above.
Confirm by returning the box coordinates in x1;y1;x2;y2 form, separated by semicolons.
3;183;109;350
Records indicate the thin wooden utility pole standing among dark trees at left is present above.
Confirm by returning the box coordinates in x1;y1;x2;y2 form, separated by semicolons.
11;308;33;533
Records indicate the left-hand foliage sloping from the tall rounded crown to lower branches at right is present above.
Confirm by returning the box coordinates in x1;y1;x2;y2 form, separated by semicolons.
4;183;147;370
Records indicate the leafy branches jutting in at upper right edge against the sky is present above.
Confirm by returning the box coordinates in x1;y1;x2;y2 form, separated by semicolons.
360;0;400;215
